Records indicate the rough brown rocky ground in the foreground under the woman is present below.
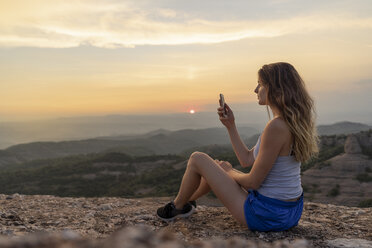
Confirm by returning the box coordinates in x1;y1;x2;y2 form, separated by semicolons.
0;194;372;247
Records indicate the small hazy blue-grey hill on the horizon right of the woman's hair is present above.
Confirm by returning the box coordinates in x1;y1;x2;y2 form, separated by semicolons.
317;121;372;135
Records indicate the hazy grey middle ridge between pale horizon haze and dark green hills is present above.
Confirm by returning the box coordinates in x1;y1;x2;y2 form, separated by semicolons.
0;127;258;167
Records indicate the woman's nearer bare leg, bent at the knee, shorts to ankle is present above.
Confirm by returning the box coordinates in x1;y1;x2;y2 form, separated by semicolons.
174;152;248;225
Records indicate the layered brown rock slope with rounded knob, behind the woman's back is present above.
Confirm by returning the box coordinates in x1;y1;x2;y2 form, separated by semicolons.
301;134;372;206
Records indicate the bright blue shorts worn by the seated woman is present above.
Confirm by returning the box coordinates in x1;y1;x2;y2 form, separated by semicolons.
244;190;304;232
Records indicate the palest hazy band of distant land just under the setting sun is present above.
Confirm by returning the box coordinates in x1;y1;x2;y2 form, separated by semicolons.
0;111;267;149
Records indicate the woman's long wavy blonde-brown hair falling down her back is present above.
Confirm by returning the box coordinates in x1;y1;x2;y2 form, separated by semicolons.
258;62;319;162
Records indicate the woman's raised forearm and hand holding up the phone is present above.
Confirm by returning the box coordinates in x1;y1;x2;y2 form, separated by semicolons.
217;104;254;167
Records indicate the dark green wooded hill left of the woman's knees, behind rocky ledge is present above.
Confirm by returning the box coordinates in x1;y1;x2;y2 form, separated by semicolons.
0;153;186;197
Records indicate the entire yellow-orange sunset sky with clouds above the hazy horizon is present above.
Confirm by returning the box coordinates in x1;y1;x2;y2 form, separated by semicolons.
0;0;372;121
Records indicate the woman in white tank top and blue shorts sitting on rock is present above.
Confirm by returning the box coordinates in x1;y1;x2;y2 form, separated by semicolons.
157;62;318;231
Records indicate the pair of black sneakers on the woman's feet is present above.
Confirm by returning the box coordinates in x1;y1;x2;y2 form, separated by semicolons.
156;202;195;222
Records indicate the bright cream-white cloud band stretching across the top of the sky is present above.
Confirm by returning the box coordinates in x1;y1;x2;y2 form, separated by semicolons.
0;0;372;48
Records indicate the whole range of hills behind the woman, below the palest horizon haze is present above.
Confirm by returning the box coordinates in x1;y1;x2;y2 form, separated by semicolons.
0;120;372;206
